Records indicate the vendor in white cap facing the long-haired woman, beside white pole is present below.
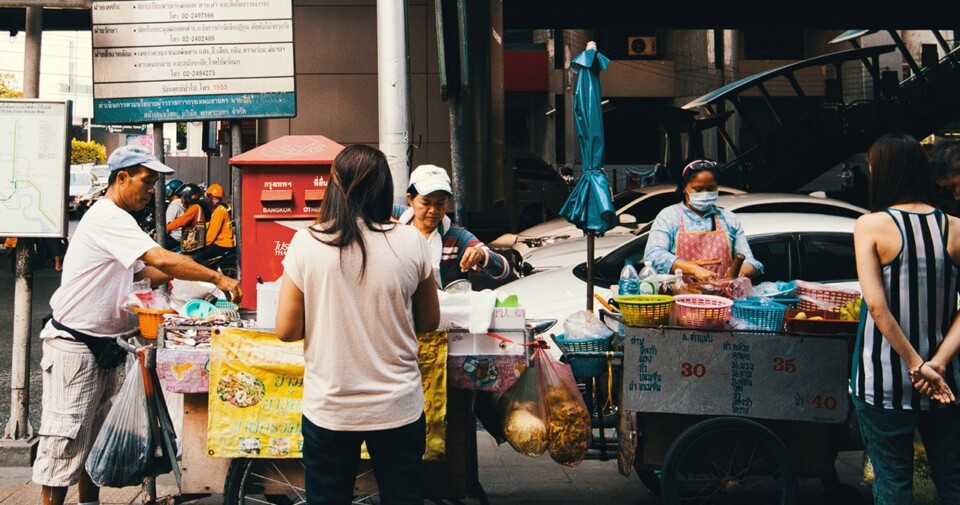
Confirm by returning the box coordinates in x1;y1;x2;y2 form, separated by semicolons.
393;165;510;287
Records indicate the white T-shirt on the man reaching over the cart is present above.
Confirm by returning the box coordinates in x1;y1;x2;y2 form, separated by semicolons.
40;198;160;338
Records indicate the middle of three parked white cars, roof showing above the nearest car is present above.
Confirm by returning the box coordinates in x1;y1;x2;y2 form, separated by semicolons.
516;193;867;276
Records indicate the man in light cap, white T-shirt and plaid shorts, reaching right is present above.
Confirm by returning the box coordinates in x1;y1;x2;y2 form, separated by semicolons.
33;146;242;505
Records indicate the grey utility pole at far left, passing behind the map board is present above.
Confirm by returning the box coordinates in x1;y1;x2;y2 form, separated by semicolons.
0;7;43;466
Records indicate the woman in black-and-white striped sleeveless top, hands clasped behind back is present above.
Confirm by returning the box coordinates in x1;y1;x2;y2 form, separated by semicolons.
851;134;960;505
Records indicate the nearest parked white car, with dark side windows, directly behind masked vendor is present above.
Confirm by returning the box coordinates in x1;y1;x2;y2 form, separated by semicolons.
498;209;859;342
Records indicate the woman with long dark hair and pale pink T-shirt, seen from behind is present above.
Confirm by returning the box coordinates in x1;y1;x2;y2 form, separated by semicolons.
276;145;440;505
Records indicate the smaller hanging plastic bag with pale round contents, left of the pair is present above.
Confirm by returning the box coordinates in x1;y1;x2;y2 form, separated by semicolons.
503;360;547;456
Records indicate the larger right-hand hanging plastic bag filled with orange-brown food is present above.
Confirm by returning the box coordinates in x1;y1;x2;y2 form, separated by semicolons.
532;348;593;467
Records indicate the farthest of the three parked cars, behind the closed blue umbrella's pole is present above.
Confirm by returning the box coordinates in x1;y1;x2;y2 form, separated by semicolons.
489;184;744;259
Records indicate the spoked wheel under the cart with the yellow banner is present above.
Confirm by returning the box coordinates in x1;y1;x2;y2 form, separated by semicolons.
223;458;376;505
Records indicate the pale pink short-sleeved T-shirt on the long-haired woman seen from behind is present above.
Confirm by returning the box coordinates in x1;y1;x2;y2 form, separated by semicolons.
283;223;433;431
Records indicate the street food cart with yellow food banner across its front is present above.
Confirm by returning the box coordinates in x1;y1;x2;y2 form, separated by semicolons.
157;307;533;503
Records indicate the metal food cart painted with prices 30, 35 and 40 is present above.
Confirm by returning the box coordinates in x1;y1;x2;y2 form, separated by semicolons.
566;320;859;505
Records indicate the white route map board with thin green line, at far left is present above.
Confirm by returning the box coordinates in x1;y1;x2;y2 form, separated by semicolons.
0;100;70;237
